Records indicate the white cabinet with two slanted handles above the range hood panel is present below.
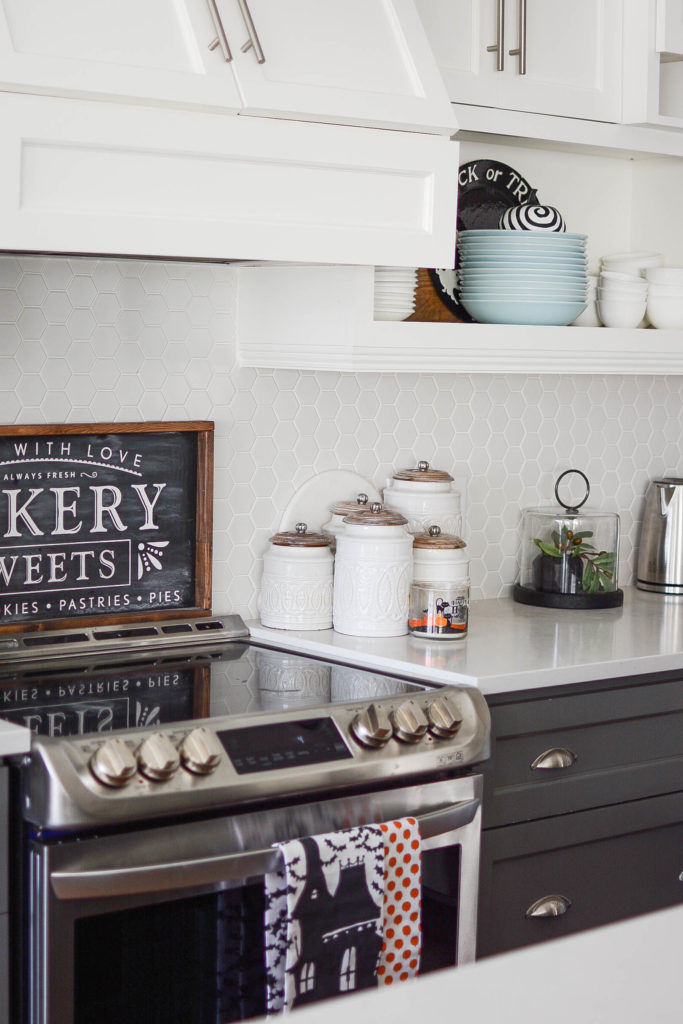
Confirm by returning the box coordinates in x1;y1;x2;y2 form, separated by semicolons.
0;0;456;134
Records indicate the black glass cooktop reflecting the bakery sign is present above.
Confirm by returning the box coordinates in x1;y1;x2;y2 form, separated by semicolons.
0;641;432;736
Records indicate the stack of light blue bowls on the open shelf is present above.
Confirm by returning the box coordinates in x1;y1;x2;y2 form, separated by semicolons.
458;228;588;327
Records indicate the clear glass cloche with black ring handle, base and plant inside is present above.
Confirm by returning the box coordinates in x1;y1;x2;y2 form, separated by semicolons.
513;469;624;608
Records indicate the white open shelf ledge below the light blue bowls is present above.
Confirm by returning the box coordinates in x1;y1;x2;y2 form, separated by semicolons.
238;264;683;375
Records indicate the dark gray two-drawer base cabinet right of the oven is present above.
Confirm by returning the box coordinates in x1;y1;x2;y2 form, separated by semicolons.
477;676;683;957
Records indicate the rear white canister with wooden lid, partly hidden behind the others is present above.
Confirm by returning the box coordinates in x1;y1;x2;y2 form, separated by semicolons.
384;461;462;535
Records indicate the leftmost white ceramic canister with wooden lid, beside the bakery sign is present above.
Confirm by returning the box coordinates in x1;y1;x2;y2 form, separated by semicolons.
259;522;334;630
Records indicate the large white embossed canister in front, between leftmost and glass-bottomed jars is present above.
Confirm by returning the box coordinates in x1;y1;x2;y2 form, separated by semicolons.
333;502;413;637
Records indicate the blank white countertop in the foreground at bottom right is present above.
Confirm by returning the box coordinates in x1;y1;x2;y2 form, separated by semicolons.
286;907;683;1024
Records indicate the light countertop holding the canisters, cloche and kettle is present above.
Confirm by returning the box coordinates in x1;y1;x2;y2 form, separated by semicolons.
247;588;683;694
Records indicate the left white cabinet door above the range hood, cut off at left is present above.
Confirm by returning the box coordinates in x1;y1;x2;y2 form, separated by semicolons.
0;0;240;111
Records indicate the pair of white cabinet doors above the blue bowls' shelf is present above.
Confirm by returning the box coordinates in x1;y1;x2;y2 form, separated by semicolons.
417;0;622;121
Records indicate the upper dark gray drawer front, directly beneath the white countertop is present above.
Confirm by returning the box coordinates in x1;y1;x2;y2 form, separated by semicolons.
484;680;683;827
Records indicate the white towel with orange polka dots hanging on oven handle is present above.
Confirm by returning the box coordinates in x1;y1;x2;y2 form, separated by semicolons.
377;818;422;985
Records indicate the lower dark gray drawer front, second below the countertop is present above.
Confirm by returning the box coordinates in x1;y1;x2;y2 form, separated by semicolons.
477;794;683;956
